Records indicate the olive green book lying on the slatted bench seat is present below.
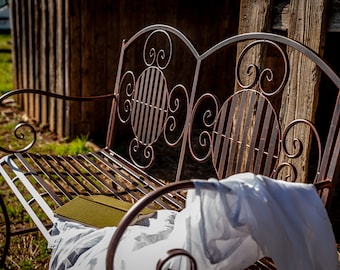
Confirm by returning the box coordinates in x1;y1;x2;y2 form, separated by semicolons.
54;195;155;228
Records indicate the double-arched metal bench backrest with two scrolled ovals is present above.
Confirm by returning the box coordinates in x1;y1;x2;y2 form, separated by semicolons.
107;25;340;206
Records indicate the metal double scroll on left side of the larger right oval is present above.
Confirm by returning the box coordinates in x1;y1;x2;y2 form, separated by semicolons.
189;93;219;162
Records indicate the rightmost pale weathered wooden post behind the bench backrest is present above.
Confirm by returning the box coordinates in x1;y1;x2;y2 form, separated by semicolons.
280;0;327;182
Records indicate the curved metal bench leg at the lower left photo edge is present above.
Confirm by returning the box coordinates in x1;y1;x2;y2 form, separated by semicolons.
0;195;11;268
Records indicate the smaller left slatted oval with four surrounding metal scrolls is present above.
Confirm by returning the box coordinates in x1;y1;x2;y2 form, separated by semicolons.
117;30;189;169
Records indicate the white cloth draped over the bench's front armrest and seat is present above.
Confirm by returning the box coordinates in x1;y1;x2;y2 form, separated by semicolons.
50;173;338;270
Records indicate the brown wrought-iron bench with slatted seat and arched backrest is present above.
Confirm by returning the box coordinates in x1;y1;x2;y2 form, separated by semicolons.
0;25;340;269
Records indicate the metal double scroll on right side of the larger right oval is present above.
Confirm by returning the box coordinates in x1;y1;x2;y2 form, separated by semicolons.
274;119;322;182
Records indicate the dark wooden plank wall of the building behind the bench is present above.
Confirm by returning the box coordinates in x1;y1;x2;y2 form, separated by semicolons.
10;0;340;143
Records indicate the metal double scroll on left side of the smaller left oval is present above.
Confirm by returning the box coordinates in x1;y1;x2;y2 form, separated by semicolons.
117;71;136;123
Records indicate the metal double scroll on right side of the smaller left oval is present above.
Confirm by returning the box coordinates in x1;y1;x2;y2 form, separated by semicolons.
163;84;189;146
